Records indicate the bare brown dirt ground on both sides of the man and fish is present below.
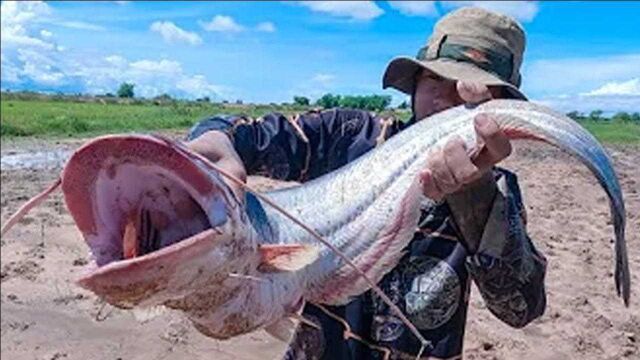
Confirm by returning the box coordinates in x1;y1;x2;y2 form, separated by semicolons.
0;141;640;360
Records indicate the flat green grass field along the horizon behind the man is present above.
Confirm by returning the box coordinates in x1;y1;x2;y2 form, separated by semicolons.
0;96;640;144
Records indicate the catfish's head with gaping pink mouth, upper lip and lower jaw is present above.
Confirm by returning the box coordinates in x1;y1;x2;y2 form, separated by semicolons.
62;135;257;308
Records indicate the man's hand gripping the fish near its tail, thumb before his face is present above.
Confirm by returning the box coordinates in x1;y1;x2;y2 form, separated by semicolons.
420;81;511;201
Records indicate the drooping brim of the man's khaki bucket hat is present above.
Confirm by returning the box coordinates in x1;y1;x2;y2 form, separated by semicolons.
382;56;527;100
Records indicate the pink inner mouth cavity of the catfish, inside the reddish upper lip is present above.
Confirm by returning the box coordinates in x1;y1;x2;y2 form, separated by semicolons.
89;164;211;266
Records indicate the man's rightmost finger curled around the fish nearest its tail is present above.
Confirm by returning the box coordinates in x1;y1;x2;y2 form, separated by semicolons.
474;114;511;169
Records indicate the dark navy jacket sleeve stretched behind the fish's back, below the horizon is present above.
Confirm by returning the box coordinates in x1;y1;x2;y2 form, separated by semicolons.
188;109;400;182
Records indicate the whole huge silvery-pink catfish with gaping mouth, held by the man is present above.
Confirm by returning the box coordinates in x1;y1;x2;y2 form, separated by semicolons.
2;100;630;339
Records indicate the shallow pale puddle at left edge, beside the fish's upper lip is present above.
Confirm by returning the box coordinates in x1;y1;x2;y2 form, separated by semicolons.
0;149;73;171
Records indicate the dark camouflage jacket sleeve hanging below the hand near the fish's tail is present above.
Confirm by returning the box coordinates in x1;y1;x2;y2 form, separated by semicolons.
466;169;546;328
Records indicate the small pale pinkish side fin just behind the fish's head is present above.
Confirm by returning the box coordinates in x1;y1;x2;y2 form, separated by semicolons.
258;244;320;272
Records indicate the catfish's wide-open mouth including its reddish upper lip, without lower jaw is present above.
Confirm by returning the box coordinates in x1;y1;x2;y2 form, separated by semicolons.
62;136;226;267
